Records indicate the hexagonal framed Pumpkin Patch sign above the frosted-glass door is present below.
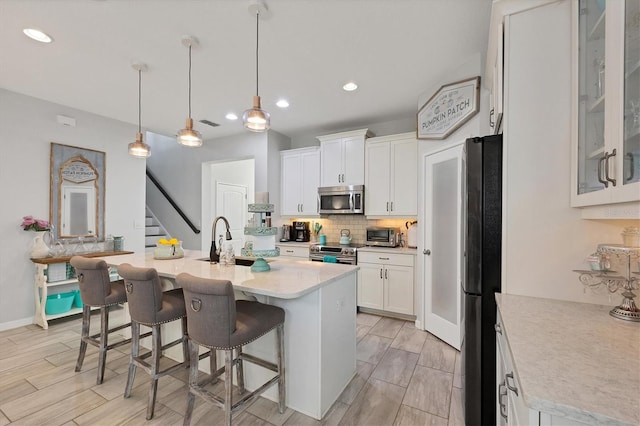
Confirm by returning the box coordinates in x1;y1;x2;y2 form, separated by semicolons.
417;77;480;139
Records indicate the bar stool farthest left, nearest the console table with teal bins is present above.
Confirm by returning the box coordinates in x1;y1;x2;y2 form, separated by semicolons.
70;256;131;384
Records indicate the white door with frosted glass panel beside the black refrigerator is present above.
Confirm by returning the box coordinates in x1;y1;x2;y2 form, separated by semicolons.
421;145;465;350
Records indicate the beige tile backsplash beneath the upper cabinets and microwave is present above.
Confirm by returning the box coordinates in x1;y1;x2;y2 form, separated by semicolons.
281;215;415;244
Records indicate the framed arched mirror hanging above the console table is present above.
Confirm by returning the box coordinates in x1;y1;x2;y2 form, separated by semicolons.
49;142;106;241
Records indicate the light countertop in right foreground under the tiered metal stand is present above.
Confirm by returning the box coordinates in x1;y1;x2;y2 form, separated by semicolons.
496;294;640;425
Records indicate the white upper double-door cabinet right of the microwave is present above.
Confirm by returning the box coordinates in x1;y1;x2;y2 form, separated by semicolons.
364;132;418;217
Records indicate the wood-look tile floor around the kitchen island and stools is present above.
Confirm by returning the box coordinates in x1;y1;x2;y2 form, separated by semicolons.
0;313;464;426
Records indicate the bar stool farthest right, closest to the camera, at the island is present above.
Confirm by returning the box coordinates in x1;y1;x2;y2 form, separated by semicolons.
176;273;286;426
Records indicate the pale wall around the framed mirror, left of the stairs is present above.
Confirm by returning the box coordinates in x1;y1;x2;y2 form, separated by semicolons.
0;89;145;329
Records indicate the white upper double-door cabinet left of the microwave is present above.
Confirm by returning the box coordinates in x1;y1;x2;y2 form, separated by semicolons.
280;147;320;217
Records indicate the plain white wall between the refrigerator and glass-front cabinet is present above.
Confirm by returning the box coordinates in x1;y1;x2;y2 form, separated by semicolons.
502;1;637;304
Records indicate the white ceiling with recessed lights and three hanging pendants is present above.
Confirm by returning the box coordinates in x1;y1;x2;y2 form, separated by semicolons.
0;0;491;139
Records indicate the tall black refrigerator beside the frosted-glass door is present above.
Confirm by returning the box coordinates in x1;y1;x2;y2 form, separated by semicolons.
460;135;502;425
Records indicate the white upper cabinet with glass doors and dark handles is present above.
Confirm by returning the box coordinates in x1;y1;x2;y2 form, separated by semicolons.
571;0;640;207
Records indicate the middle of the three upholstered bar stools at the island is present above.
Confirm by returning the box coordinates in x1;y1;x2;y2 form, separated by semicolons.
118;263;189;420
